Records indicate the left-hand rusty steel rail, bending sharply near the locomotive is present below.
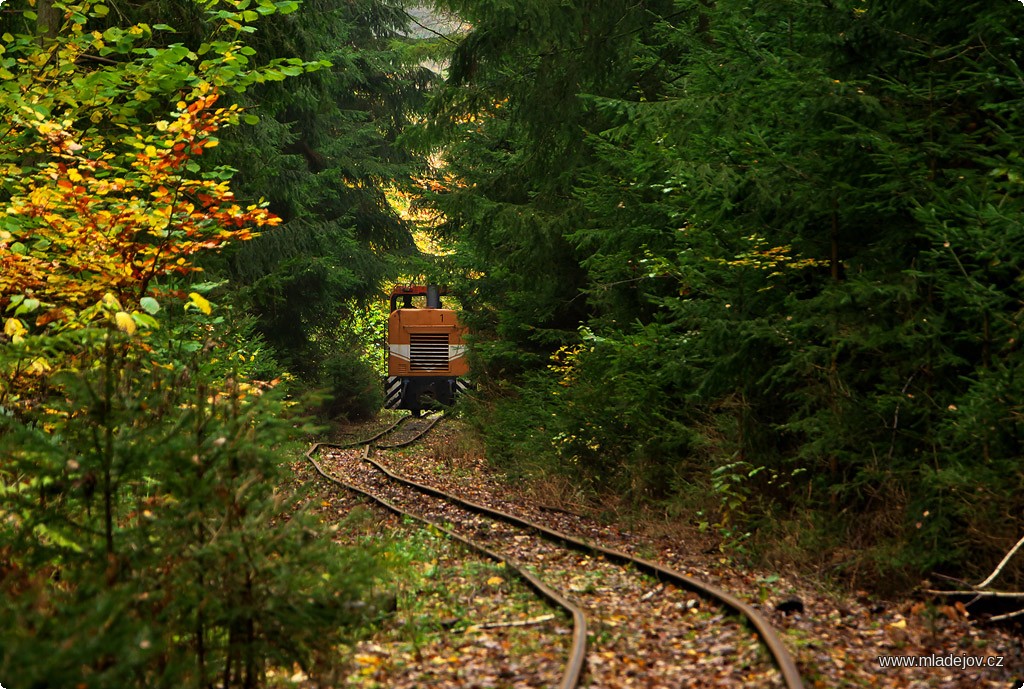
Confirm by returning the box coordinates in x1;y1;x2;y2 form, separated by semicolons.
305;440;587;689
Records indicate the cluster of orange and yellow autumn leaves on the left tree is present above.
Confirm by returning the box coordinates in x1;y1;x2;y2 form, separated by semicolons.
0;93;279;332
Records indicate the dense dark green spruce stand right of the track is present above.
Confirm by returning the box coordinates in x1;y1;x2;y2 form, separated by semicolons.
419;2;1024;572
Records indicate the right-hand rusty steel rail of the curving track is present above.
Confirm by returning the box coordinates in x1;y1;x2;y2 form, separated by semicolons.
358;445;804;689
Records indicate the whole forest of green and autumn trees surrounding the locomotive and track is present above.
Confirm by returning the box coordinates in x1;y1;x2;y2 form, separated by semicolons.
0;0;1024;689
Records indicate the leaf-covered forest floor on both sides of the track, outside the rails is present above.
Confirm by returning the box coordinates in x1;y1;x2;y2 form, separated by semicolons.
294;413;1024;689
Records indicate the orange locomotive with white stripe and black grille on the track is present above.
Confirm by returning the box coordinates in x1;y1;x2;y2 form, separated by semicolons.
384;285;469;414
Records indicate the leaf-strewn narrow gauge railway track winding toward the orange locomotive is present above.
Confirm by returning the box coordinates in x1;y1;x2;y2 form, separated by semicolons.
306;417;803;689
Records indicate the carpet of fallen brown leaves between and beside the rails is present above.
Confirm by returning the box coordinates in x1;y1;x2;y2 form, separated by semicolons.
286;415;1024;689
